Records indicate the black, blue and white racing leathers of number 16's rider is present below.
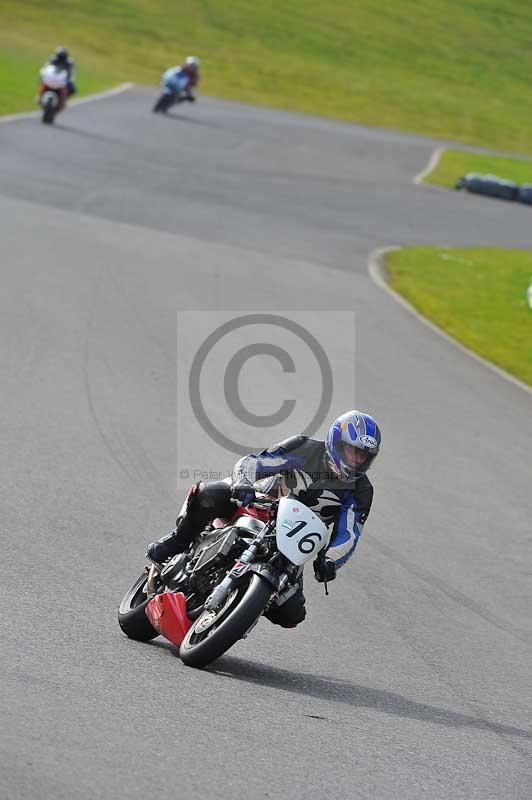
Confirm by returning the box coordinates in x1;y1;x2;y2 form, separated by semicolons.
147;436;373;627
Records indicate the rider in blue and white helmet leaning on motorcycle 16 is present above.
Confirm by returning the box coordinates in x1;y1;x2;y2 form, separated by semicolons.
146;411;381;628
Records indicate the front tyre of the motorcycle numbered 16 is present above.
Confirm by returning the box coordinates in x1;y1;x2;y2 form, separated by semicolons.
179;573;273;667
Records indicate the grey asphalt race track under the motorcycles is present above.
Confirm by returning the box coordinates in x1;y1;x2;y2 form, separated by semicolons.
0;88;532;800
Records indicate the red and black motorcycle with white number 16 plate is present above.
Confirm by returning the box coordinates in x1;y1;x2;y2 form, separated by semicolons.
118;496;329;667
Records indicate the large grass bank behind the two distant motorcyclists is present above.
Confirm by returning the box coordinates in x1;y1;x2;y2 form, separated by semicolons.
0;0;532;152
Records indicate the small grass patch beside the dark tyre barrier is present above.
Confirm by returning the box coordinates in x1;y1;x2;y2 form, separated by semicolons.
424;150;532;189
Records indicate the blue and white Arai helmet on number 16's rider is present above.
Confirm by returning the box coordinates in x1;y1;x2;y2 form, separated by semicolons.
325;411;381;481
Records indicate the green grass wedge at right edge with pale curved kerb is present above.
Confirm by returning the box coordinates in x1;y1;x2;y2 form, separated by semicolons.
386;247;532;386
